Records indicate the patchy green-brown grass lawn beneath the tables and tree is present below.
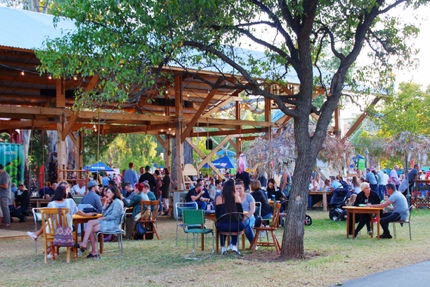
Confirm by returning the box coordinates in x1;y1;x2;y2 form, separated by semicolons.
0;209;430;286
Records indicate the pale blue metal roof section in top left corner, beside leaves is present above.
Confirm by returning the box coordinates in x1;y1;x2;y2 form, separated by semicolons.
0;7;76;50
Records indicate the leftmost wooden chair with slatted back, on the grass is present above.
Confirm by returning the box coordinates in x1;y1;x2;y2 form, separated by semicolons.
40;208;72;263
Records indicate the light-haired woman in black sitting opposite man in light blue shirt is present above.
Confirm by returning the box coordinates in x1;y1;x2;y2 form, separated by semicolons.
350;182;381;237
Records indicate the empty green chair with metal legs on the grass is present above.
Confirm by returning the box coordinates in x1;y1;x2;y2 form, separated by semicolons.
182;209;214;260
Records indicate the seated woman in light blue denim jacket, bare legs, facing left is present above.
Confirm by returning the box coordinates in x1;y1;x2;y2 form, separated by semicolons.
75;186;123;258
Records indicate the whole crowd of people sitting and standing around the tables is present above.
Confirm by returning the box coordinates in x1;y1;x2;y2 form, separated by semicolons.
0;160;420;258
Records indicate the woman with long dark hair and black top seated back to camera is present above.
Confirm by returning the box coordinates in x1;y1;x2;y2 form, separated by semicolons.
215;179;244;255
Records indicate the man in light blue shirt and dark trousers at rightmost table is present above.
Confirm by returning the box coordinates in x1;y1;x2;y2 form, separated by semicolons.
373;183;409;239
